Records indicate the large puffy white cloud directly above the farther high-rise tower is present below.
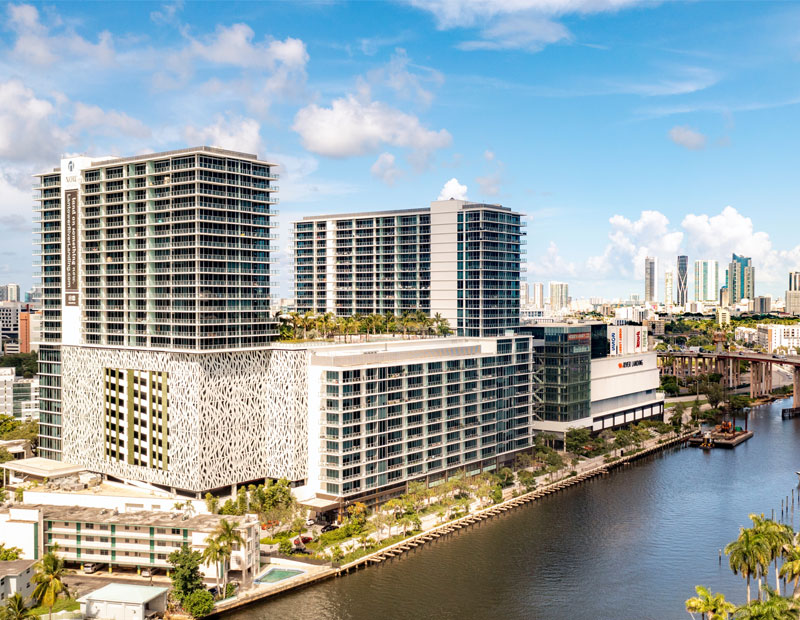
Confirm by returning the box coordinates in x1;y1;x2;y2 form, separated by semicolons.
292;94;451;157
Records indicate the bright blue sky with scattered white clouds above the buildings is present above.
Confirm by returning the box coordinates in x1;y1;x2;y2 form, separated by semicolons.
0;0;800;298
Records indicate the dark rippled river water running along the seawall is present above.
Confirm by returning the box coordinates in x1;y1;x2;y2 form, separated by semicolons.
226;401;800;620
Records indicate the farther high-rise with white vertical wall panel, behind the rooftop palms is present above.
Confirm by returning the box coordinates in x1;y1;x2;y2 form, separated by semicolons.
293;199;525;337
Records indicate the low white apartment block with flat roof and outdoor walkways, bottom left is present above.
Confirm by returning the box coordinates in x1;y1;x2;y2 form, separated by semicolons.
0;504;260;582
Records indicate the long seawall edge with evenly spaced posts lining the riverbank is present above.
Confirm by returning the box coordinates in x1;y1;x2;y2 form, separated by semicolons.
208;432;692;618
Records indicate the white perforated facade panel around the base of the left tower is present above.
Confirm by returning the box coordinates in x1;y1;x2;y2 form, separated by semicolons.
62;346;308;492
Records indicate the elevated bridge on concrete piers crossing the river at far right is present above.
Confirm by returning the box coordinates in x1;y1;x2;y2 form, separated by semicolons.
658;351;800;409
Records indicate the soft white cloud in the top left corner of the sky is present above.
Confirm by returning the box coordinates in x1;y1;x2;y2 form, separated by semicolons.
7;4;115;66
